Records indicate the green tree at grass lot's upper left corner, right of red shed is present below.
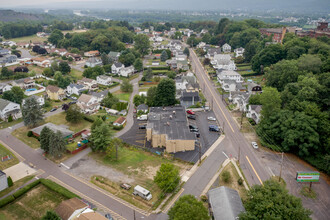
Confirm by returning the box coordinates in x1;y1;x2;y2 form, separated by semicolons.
90;123;112;152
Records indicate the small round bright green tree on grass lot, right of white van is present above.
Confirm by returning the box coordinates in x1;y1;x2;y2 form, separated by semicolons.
154;163;180;193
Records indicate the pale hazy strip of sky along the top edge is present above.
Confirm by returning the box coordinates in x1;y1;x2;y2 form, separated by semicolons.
0;0;330;11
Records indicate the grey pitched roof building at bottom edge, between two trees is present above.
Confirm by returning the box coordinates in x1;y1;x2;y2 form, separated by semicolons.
207;186;245;220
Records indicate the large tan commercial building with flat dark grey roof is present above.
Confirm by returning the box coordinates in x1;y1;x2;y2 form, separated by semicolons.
146;106;195;153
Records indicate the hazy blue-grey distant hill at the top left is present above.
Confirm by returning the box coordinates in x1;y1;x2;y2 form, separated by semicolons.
0;10;44;22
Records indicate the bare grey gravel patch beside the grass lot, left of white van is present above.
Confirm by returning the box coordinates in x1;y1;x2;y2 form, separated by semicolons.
69;156;135;183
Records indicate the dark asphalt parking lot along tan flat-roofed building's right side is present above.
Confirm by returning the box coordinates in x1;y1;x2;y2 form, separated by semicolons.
174;111;220;163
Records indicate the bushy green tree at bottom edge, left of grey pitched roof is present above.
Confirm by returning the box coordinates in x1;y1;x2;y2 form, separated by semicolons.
168;195;210;220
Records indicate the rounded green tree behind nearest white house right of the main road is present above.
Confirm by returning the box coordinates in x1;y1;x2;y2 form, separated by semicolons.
260;87;281;118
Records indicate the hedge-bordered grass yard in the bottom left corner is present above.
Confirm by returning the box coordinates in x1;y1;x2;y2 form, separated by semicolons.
0;184;66;220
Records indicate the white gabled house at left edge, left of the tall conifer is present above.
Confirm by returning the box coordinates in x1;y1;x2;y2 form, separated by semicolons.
0;99;22;121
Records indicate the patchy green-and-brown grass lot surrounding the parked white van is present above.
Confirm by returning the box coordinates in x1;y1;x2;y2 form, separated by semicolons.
90;147;181;210
